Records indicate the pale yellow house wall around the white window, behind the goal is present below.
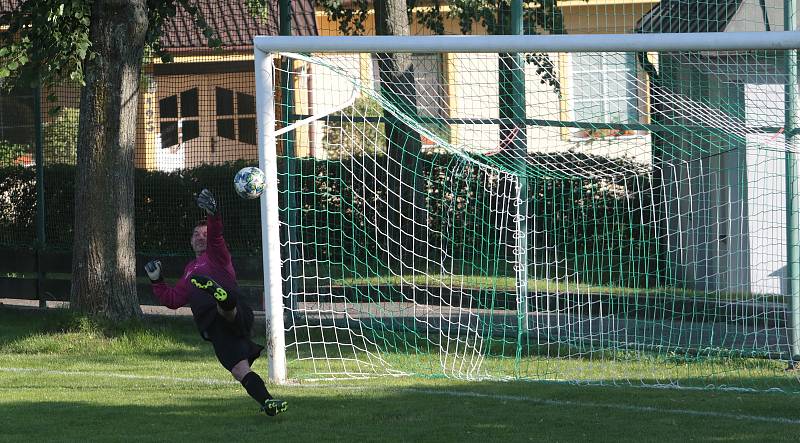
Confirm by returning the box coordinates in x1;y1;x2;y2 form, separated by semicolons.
296;1;657;163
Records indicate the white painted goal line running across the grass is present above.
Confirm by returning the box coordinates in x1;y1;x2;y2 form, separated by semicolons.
0;367;800;425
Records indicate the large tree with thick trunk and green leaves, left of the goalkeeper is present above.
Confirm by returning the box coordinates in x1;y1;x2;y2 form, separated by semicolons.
0;0;222;321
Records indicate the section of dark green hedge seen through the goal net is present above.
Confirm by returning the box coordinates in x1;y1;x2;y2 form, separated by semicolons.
282;153;663;286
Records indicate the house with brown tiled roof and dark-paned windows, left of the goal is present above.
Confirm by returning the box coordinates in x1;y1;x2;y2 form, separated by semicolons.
136;0;317;171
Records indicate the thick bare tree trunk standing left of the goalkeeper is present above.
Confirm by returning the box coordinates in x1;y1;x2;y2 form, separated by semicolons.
70;0;148;321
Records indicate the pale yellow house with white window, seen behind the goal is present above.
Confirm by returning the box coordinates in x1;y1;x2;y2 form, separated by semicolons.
293;0;658;162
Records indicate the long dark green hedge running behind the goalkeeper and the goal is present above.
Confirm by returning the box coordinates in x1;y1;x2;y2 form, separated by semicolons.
0;154;659;286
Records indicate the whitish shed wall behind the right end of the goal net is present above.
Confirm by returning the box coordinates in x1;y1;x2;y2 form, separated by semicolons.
656;53;786;294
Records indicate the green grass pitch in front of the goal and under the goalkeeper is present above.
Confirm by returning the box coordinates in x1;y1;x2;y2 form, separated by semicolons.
0;307;800;442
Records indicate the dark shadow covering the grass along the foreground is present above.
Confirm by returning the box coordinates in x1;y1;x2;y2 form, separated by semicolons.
0;383;800;441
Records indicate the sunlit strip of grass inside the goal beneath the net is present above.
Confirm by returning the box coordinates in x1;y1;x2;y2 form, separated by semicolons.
286;320;800;394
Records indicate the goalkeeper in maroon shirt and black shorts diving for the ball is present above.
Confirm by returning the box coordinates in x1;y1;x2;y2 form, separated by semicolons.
145;189;287;415
